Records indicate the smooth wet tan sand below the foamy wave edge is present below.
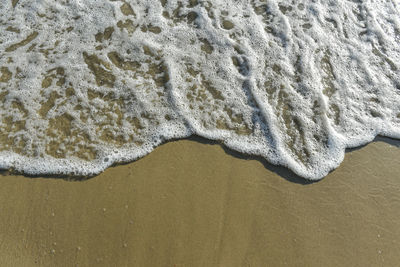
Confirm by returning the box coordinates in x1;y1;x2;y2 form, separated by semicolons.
0;139;400;267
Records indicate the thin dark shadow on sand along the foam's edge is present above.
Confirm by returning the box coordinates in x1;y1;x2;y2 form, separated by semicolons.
0;135;400;185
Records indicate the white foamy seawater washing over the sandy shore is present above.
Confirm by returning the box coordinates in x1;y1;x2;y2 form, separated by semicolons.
0;0;400;179
